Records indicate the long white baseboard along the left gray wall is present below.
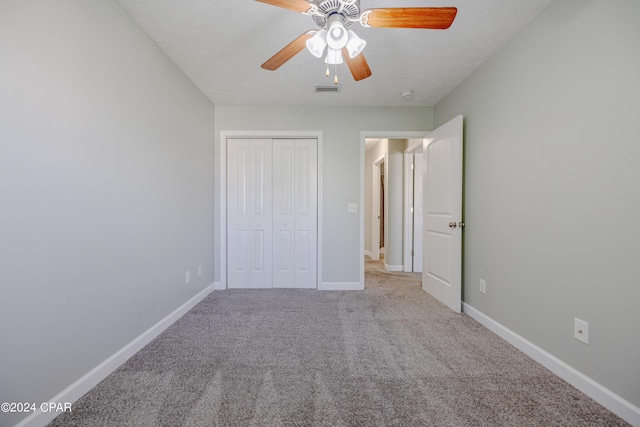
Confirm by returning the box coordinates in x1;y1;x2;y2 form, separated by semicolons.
15;284;214;427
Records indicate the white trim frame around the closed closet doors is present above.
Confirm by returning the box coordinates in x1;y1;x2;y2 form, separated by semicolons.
216;130;322;290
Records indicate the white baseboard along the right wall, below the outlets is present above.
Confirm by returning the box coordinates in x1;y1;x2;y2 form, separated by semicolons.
462;303;640;427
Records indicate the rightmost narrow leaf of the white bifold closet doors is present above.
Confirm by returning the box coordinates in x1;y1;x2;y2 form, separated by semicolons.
294;139;318;289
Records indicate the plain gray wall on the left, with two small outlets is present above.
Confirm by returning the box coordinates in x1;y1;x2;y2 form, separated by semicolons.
0;0;214;425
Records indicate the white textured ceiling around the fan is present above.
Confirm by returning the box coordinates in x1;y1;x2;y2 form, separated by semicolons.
116;0;553;106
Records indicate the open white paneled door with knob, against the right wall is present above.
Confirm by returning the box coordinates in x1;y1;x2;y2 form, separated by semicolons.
422;116;463;313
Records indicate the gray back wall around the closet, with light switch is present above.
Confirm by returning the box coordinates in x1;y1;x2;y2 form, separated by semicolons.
215;106;433;283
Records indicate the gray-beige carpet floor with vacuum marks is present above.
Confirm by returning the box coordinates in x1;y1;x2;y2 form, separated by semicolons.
50;262;627;426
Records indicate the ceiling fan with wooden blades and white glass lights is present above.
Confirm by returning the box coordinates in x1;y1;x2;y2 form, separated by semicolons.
256;0;458;84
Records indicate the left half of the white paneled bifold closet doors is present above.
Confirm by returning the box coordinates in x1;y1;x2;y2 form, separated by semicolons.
227;139;272;288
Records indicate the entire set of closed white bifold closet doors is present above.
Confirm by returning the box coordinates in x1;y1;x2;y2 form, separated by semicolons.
227;139;318;289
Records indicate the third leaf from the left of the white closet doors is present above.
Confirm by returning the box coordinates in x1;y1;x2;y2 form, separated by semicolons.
273;139;295;288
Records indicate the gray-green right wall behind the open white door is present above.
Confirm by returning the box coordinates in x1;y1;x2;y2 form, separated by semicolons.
435;0;640;406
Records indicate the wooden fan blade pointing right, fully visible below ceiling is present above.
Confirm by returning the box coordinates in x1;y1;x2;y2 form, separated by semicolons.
363;7;458;30
